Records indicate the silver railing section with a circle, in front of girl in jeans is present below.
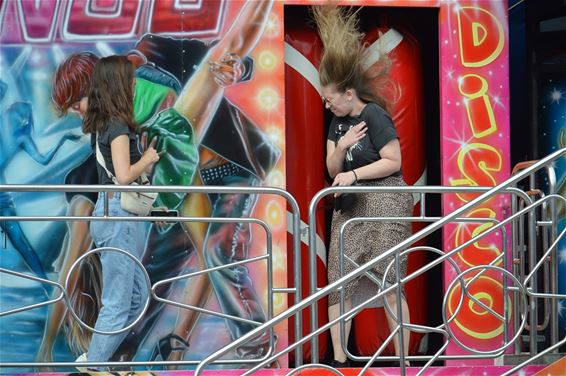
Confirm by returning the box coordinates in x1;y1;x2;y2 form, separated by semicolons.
0;185;302;368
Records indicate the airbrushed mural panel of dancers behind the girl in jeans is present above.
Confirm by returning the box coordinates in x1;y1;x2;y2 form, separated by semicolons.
0;0;287;368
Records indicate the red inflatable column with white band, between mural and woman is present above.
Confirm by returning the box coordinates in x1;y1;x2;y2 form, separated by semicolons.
285;22;328;360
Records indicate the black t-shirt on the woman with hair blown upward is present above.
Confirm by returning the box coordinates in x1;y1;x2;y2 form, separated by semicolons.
327;103;399;175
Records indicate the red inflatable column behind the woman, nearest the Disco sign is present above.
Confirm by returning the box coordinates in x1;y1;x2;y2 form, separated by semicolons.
354;27;427;355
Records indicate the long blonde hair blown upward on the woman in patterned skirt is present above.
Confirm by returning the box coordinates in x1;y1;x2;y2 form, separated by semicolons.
312;5;392;111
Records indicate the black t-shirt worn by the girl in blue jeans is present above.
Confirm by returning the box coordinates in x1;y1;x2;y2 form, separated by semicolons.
90;120;141;184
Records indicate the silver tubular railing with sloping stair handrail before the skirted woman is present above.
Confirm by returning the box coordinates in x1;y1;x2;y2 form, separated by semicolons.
196;149;566;375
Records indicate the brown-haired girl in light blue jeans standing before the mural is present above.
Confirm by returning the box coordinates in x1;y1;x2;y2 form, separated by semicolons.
79;56;159;362
